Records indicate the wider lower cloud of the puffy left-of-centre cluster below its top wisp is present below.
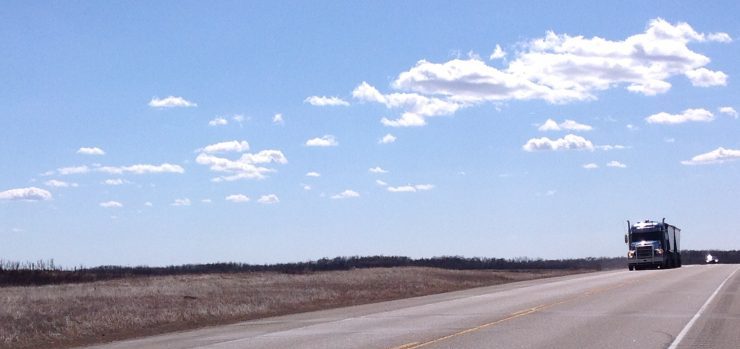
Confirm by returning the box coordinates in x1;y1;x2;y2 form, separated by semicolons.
195;149;288;182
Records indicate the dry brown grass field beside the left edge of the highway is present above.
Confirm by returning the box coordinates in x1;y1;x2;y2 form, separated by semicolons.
0;267;588;348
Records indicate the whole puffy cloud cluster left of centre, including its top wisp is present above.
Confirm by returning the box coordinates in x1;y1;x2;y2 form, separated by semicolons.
195;141;288;182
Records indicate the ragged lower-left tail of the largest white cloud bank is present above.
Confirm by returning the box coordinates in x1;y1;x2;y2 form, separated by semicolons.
352;81;463;127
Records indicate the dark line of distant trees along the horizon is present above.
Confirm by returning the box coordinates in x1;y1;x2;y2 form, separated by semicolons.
0;250;740;287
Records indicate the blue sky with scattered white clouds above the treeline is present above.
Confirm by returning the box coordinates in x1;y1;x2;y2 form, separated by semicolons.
0;1;740;266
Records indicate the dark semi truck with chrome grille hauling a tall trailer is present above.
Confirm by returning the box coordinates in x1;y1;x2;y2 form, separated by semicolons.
624;218;681;270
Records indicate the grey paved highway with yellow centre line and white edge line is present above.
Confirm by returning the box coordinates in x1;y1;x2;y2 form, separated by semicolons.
82;264;740;349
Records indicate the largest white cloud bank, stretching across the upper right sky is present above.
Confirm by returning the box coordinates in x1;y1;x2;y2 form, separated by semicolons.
352;18;731;127
